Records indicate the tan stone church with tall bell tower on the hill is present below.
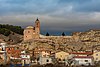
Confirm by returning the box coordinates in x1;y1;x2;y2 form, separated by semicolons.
24;18;40;41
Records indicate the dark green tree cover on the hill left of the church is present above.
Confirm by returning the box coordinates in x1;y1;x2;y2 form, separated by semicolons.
0;24;24;36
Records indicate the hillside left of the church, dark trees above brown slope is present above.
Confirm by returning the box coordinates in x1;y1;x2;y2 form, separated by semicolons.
0;24;23;44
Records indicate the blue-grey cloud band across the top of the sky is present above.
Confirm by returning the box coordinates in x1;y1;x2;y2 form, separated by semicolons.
0;0;100;14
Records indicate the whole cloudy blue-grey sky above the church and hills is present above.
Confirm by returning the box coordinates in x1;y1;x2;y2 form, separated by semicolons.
0;0;100;34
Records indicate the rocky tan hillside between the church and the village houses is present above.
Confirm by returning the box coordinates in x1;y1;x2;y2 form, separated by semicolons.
21;30;100;52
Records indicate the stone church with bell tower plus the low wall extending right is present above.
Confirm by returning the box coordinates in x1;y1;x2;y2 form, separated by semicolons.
24;18;79;41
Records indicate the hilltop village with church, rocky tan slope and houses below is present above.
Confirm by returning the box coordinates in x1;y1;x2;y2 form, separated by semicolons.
0;18;100;66
